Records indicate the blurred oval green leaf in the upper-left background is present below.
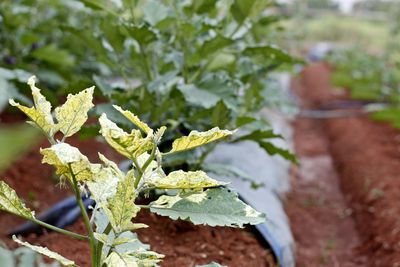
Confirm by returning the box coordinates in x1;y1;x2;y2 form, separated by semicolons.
32;44;75;67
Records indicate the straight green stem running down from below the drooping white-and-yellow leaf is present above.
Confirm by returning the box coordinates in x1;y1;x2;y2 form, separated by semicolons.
68;164;101;267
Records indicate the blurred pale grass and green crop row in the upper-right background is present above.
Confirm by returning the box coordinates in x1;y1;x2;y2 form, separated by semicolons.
280;0;400;127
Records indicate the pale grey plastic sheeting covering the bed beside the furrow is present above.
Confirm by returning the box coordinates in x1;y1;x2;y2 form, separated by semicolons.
206;74;295;267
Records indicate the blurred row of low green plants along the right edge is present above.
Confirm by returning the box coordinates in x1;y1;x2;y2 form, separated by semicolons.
329;45;400;128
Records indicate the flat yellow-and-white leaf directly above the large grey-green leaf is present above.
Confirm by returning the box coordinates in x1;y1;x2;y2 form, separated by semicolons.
150;170;226;189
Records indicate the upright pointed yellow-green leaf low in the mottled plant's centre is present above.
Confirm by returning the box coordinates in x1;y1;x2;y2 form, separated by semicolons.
102;172;140;233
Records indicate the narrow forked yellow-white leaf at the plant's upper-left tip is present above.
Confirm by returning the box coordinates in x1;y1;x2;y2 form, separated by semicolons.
10;76;56;136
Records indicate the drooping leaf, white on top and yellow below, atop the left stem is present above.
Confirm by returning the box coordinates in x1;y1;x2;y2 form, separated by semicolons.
40;143;96;184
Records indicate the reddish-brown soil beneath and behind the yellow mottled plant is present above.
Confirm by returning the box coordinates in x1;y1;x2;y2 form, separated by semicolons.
0;122;275;267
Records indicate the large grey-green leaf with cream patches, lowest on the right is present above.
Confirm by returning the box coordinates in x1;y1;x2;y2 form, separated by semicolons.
150;188;265;227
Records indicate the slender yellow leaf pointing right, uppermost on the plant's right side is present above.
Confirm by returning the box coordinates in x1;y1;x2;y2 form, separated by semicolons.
169;127;234;153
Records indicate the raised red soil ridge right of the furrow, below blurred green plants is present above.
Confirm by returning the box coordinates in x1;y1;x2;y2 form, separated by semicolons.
294;64;400;266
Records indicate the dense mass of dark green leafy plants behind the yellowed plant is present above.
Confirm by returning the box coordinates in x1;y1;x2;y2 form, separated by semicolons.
3;0;296;180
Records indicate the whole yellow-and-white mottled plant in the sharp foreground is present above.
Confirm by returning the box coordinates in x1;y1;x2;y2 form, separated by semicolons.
0;77;265;267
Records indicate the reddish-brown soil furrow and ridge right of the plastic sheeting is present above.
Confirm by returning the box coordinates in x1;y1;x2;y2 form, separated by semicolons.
288;64;400;266
